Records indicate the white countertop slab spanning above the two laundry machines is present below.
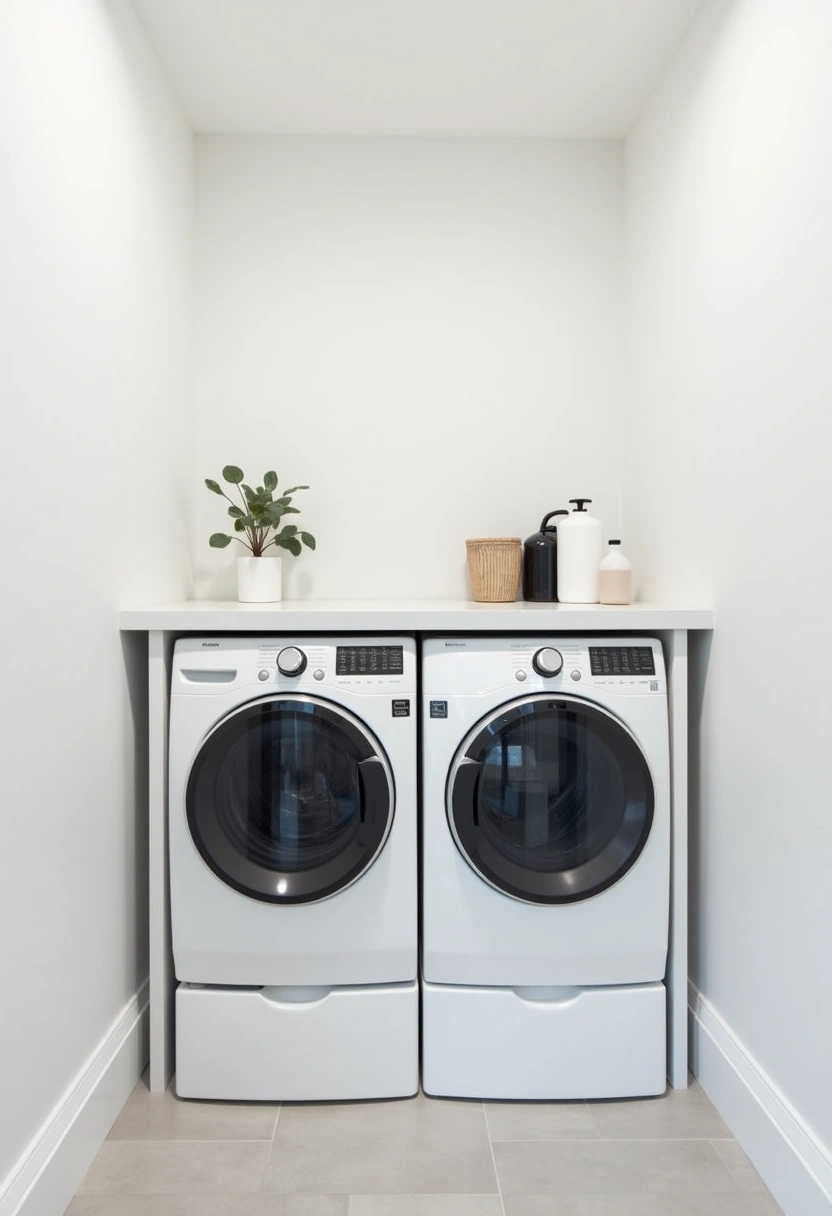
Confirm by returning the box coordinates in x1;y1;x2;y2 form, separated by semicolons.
119;599;714;634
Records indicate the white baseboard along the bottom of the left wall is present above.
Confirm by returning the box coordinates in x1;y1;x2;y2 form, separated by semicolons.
0;980;148;1216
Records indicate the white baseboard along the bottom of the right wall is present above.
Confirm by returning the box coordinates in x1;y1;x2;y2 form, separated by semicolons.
688;984;832;1216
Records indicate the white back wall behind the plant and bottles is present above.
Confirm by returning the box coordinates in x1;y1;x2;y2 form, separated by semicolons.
196;136;623;598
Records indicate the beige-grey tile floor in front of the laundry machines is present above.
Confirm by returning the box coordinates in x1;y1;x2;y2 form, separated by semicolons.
67;1077;780;1216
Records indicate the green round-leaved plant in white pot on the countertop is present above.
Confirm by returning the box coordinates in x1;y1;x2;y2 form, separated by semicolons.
206;465;315;603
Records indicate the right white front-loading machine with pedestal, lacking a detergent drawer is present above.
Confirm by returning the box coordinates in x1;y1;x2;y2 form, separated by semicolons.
422;636;670;1099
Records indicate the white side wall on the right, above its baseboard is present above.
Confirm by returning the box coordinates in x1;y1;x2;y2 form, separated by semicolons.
624;0;832;1186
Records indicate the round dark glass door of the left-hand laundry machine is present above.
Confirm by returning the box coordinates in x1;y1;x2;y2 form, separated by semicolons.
186;696;394;903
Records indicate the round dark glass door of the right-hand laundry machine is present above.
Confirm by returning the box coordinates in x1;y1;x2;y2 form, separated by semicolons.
448;697;654;903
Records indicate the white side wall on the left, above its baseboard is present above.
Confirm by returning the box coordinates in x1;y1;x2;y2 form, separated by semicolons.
0;0;192;1190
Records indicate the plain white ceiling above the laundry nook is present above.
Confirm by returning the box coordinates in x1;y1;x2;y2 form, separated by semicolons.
133;0;699;139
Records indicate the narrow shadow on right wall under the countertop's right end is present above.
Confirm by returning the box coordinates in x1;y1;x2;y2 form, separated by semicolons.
687;630;713;987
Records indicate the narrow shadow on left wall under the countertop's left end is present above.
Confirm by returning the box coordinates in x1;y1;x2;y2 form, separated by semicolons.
122;631;150;991
